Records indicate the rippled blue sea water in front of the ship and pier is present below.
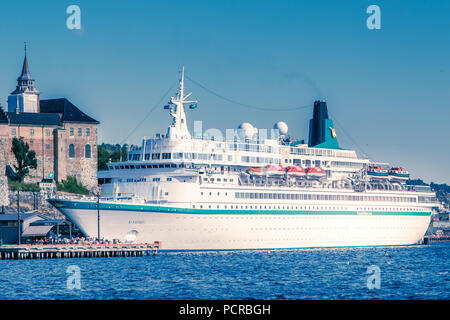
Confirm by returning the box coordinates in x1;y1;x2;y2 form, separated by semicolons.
0;243;450;300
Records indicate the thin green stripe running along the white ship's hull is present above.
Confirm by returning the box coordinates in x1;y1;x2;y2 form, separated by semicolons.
49;199;431;216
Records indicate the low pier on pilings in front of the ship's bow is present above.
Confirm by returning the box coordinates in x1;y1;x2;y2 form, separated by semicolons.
0;241;161;260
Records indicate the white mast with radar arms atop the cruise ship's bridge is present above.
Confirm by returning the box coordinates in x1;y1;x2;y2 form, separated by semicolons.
166;66;197;140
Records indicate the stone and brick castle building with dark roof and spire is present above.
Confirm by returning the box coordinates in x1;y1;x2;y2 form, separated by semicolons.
0;55;99;191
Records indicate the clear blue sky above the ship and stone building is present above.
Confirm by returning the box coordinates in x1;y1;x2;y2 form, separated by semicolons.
0;0;450;183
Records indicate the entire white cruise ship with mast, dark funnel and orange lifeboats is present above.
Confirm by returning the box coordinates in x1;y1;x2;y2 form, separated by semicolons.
48;68;436;250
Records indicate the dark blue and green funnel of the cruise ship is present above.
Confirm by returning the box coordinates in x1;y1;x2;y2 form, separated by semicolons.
308;101;339;149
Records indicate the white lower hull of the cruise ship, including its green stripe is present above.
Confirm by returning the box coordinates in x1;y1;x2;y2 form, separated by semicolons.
47;200;430;250
